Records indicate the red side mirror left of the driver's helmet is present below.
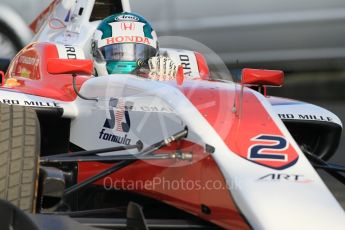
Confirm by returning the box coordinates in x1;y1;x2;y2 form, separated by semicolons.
47;58;93;75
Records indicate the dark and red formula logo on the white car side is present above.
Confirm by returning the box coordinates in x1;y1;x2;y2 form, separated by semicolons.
98;98;133;145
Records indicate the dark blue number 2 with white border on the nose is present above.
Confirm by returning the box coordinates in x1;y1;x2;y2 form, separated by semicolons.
248;134;288;161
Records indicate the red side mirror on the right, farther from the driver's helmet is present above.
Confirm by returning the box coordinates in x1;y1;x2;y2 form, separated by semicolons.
241;68;284;86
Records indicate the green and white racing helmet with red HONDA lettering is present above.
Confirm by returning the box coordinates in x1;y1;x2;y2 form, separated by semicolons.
91;12;158;75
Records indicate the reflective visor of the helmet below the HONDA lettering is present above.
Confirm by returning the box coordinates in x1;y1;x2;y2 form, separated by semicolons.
100;43;157;62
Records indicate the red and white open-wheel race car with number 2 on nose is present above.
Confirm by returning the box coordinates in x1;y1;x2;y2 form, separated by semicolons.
0;0;345;229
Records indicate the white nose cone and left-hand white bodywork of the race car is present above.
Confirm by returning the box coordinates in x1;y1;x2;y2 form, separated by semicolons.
0;75;345;229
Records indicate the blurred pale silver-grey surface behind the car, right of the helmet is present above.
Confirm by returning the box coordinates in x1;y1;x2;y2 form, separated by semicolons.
130;0;345;70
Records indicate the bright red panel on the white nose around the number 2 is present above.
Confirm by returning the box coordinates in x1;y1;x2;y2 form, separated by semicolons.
183;83;298;169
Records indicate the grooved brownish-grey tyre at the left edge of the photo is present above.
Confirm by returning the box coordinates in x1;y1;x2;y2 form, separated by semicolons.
0;103;40;212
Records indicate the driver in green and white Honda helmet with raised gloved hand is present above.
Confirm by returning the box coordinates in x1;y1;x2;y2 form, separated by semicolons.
92;12;178;80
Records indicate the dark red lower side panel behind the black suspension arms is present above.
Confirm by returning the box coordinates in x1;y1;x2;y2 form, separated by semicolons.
78;141;250;229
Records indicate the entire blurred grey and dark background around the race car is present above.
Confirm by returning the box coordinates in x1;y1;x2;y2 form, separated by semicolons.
0;0;345;207
